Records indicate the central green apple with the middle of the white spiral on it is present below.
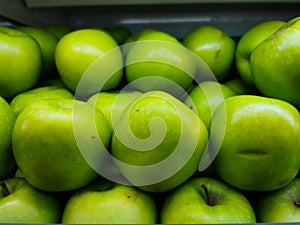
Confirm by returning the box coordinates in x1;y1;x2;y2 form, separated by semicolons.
111;91;208;192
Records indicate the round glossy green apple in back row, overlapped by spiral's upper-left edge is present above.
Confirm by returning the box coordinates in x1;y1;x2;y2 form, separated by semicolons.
55;29;123;96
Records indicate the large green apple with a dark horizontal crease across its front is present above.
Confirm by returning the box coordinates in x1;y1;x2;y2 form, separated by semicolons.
211;95;300;191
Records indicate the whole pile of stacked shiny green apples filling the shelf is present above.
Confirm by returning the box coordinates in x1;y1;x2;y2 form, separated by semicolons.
0;14;300;224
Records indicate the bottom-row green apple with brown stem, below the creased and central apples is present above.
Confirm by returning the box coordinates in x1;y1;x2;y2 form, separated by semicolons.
161;177;256;224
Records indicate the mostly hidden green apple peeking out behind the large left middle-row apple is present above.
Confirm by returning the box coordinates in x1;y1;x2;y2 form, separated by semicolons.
10;86;74;116
